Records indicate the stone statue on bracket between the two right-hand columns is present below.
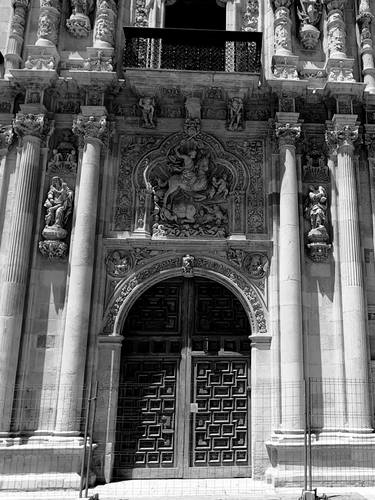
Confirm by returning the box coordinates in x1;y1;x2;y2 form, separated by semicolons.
305;186;331;262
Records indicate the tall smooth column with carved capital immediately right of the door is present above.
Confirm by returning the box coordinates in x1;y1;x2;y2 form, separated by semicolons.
276;113;304;433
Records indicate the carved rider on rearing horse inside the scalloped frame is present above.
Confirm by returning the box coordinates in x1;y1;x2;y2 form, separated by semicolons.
150;140;231;237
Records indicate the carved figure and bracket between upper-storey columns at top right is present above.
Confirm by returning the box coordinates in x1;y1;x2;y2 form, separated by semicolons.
297;0;323;50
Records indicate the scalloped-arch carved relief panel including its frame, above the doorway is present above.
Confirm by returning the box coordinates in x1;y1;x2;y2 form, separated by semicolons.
133;129;253;238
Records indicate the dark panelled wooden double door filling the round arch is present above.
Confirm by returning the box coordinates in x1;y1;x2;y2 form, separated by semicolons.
114;278;251;479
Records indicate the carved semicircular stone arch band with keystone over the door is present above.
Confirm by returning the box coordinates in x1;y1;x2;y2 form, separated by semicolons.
103;254;267;335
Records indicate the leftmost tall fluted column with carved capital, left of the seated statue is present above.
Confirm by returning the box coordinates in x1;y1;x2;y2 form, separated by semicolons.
0;113;46;435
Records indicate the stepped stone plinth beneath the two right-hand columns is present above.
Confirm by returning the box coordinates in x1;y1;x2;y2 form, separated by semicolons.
265;430;375;488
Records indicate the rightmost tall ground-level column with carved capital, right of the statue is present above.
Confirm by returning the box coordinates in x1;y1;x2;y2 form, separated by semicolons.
326;115;371;432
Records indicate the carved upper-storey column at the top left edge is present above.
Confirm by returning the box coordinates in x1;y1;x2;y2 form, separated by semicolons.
4;0;29;78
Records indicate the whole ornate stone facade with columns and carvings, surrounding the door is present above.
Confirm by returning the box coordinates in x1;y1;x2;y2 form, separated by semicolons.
0;0;375;489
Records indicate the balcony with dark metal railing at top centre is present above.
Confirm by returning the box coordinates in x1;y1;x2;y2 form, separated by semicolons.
123;27;262;92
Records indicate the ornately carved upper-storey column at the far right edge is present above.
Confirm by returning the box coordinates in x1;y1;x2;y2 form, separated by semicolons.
357;0;375;94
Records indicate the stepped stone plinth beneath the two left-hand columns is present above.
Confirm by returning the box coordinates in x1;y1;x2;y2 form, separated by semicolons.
0;435;90;491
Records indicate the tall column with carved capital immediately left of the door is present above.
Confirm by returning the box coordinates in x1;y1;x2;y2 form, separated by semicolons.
56;108;107;435
